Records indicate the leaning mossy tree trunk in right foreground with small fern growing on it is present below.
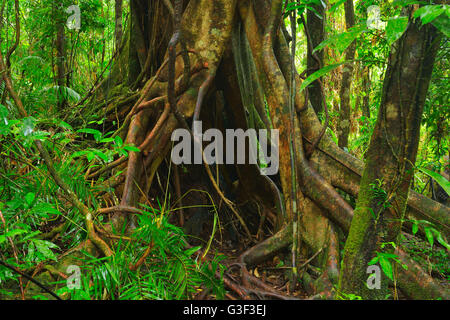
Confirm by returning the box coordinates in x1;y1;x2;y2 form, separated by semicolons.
339;10;439;299
